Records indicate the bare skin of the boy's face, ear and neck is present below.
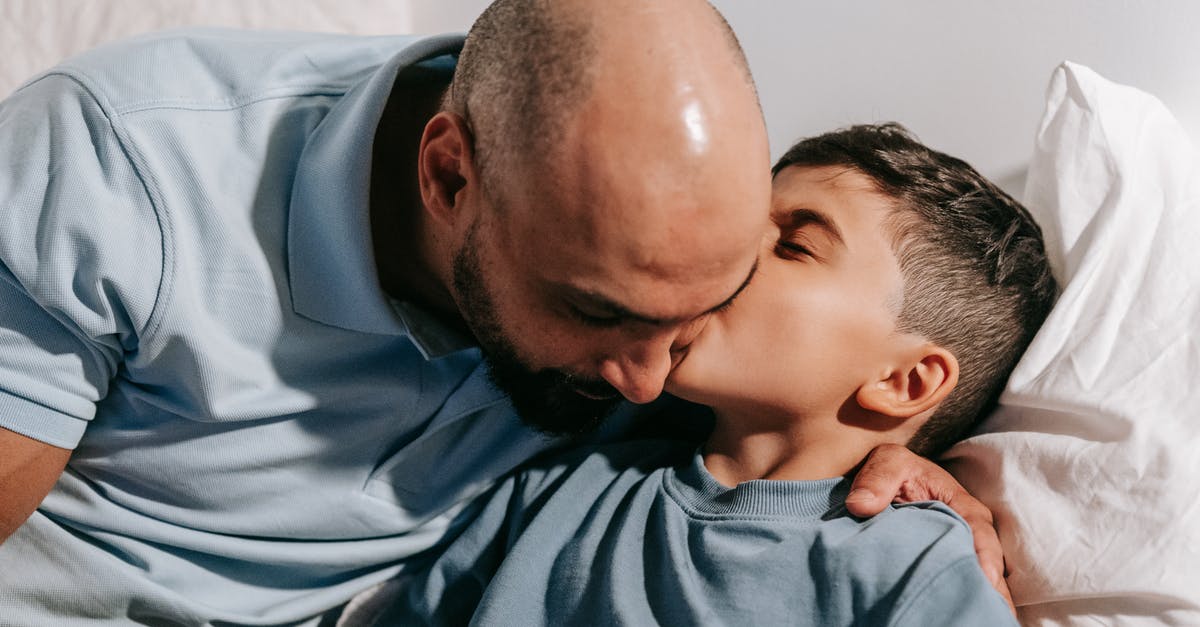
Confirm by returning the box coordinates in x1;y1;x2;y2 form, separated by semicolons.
668;166;959;485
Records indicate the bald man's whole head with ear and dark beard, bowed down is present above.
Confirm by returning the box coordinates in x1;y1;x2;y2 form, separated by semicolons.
419;0;770;431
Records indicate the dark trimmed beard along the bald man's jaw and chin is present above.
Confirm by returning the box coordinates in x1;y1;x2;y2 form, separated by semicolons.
454;222;620;435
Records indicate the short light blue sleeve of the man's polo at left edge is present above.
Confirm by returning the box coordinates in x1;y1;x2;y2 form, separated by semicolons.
0;73;163;448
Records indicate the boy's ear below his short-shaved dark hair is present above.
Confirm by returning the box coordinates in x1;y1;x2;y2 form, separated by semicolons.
856;344;959;419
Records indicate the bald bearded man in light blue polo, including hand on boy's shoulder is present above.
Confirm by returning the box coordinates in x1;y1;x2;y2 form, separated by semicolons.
0;0;1000;625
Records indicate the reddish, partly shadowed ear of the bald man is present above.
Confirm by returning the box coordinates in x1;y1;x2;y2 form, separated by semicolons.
416;112;476;226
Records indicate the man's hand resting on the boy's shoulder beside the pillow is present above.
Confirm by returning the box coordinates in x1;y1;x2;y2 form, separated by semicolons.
846;444;1015;614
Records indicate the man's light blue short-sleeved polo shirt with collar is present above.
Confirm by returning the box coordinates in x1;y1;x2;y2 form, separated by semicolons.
0;30;609;625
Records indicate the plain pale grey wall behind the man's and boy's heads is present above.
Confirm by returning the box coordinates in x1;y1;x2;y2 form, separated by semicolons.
410;0;1200;192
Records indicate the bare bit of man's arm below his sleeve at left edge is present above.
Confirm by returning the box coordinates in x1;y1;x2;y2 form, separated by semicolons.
0;428;71;543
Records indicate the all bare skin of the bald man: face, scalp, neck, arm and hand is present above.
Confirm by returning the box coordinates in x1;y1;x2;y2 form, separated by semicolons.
0;0;1002;605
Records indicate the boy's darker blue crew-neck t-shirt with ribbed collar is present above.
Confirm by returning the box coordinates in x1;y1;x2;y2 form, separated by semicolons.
378;441;1016;627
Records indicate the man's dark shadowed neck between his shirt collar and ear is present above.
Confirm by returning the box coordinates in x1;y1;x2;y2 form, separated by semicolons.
371;66;464;327
